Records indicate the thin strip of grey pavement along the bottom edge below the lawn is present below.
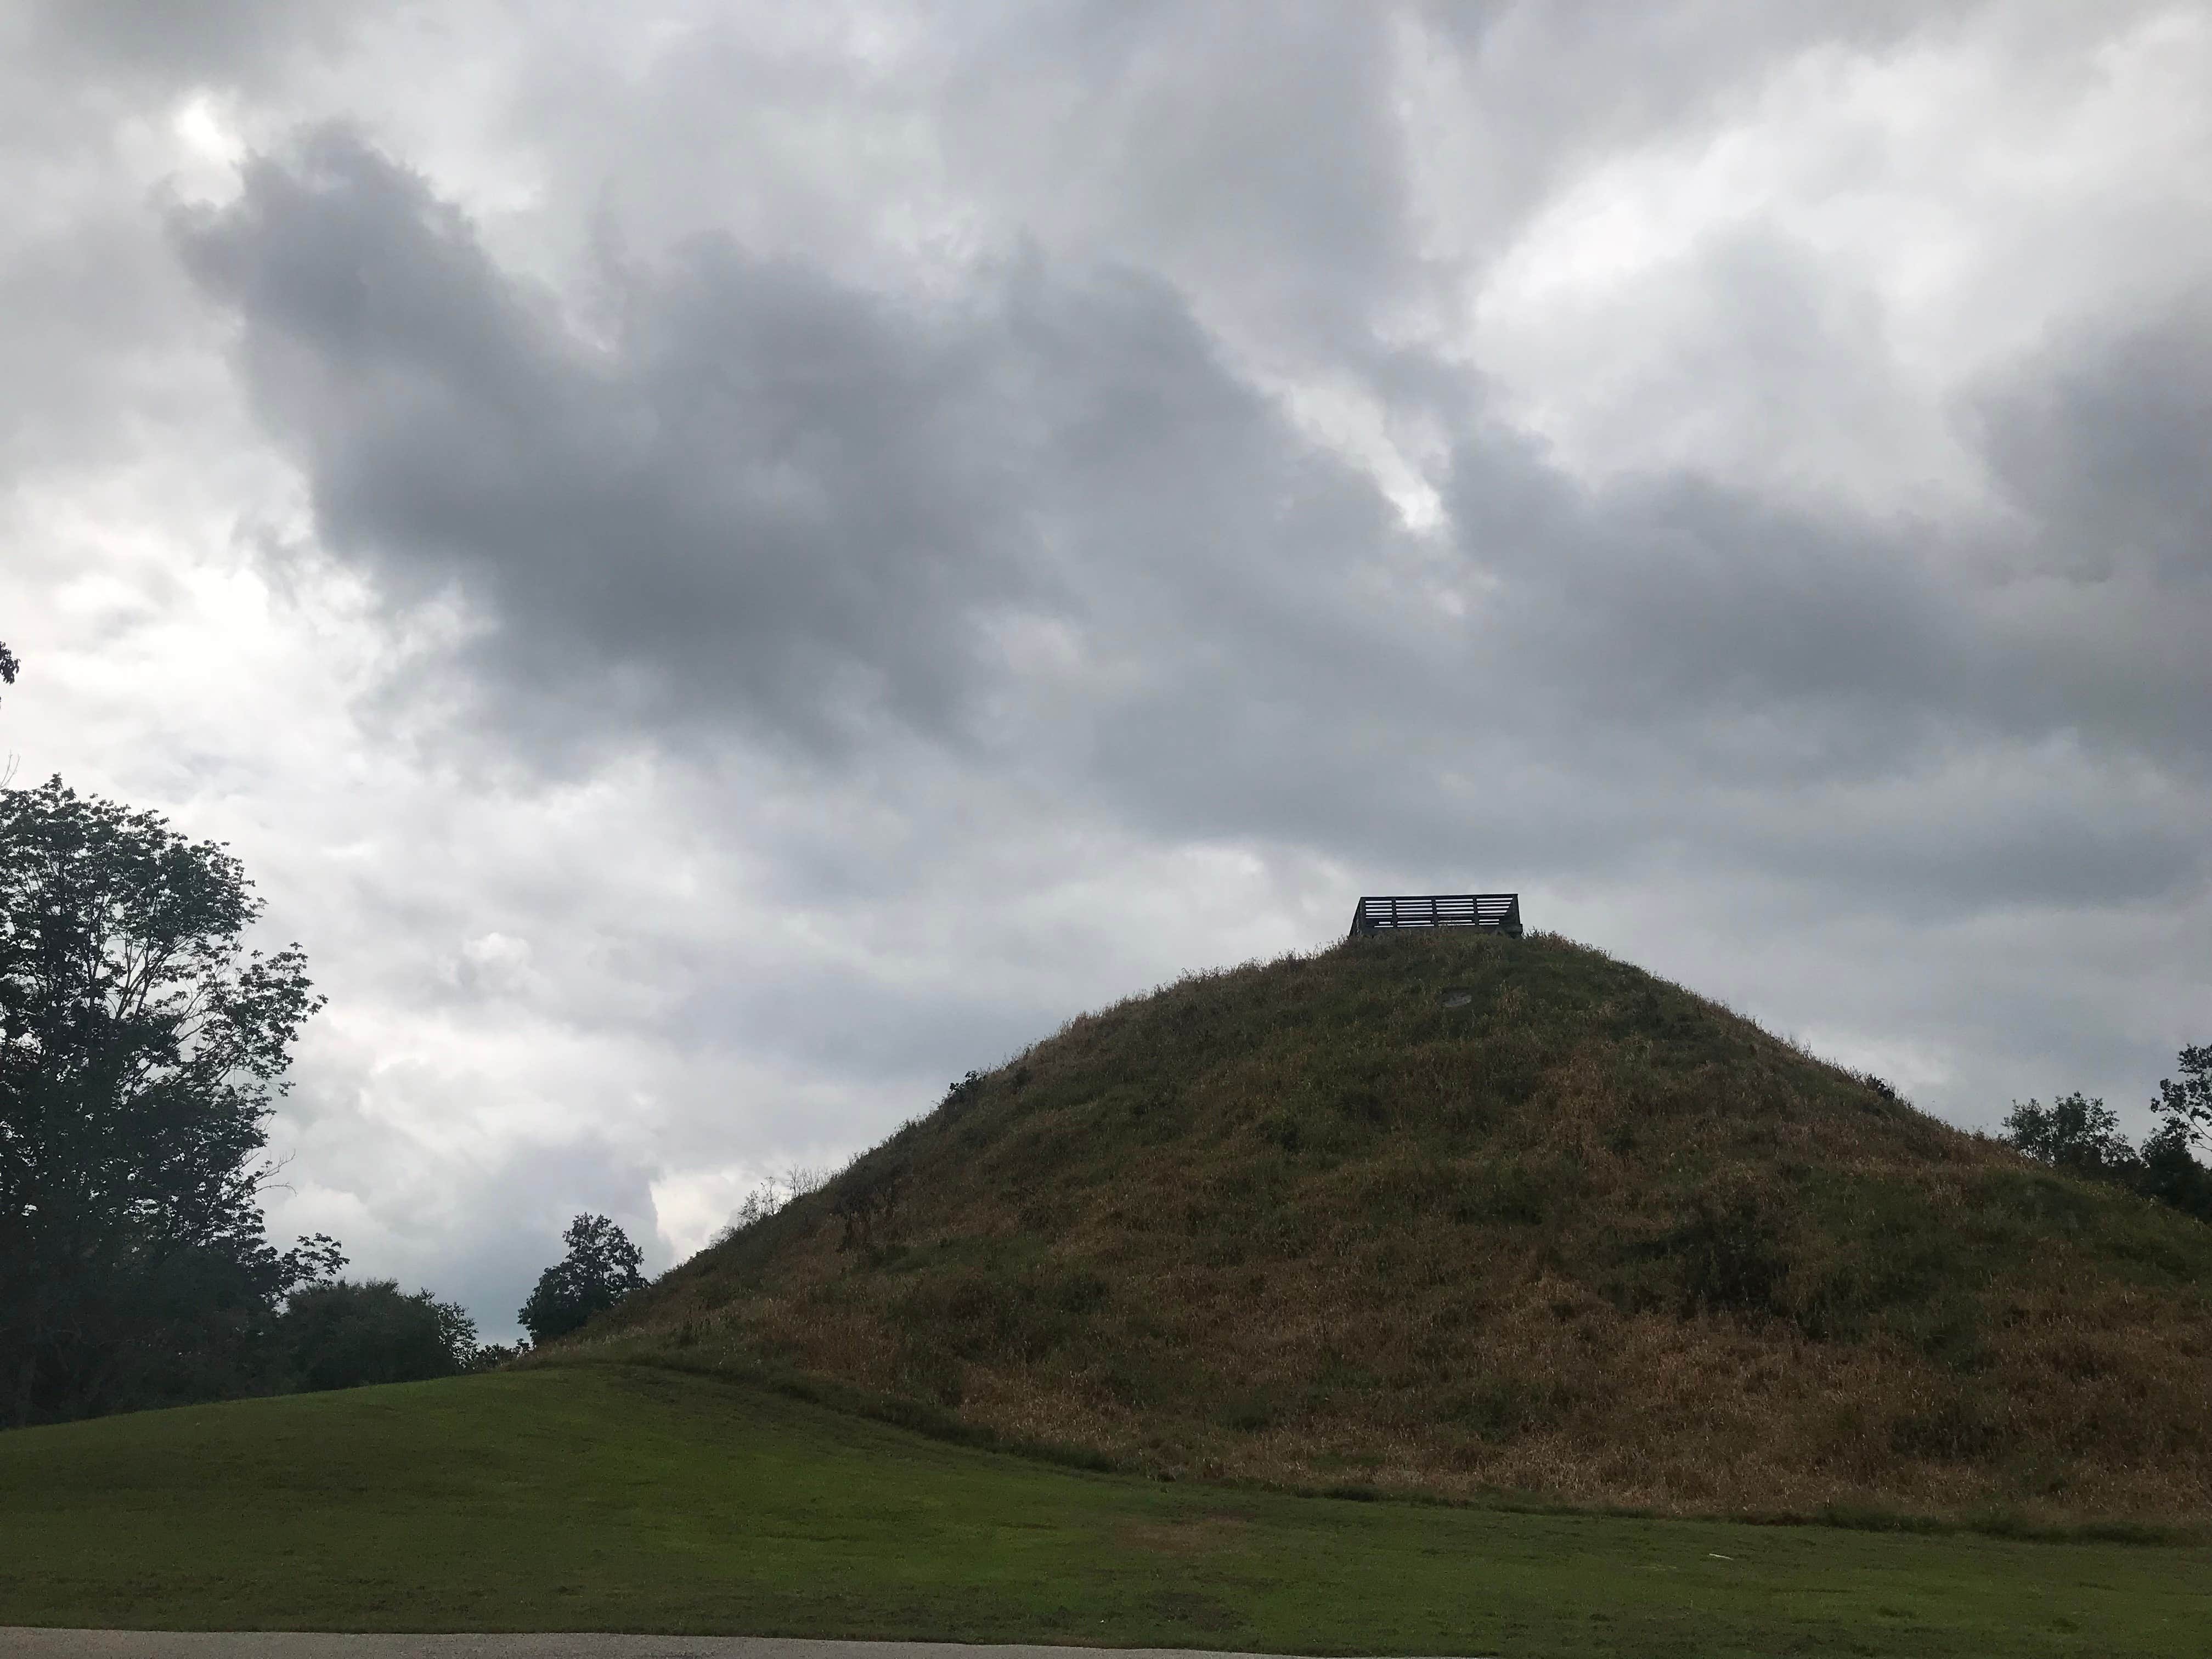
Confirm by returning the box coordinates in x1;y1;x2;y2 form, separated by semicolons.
0;1626;1415;1659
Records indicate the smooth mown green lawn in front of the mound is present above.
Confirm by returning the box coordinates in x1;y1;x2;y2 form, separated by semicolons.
0;1365;2212;1659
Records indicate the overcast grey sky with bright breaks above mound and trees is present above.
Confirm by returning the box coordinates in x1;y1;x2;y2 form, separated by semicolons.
0;0;2212;1334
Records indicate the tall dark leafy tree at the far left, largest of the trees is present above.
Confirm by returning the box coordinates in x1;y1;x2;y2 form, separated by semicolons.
0;778;329;1425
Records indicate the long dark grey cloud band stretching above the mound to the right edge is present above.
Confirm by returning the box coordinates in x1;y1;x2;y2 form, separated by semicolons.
182;118;2205;924
